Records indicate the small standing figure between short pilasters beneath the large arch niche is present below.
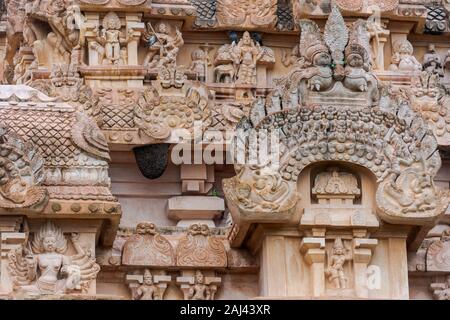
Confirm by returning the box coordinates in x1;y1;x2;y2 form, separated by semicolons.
325;238;352;289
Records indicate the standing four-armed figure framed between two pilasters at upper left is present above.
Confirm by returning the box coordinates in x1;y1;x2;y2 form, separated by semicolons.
92;12;133;65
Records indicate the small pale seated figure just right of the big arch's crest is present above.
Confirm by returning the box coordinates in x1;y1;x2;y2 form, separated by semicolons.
389;39;422;71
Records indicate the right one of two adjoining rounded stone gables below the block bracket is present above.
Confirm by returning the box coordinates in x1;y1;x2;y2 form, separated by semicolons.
176;224;227;267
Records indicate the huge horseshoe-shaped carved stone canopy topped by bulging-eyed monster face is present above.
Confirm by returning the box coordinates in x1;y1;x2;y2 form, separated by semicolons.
223;8;447;242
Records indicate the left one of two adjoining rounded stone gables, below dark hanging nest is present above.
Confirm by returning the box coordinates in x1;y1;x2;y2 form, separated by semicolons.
122;222;175;267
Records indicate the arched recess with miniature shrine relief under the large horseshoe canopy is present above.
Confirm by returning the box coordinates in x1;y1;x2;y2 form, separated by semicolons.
297;162;379;228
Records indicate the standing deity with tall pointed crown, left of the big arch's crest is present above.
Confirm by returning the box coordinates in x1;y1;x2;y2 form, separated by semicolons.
232;31;264;85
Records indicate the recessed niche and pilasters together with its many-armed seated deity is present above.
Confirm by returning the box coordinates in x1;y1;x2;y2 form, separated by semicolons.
1;220;100;299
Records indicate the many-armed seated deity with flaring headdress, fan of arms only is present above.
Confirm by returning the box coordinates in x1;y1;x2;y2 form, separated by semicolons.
9;222;100;295
